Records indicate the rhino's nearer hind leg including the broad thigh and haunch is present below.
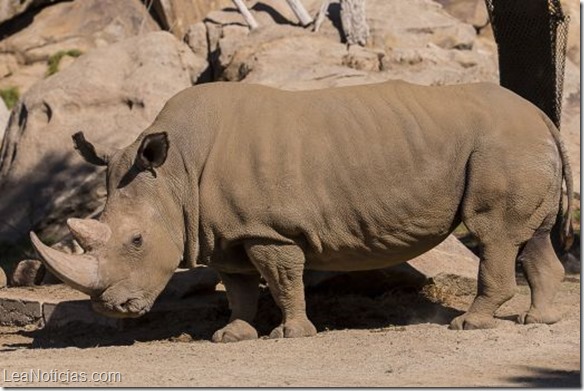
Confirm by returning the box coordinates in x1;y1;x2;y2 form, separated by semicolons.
451;145;562;329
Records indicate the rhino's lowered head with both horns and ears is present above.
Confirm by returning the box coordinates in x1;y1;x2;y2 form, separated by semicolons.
31;133;184;317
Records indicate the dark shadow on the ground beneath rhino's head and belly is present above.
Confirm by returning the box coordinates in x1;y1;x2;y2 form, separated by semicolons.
1;287;461;351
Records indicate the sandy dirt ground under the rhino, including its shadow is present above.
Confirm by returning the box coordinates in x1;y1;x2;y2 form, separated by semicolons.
0;275;581;387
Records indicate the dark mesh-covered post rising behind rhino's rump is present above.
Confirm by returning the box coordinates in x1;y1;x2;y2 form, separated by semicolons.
485;0;569;128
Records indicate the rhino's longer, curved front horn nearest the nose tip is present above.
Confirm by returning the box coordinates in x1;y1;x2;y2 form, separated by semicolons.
30;231;100;296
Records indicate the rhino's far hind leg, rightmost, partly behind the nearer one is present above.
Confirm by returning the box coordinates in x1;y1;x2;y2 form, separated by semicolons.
519;232;564;324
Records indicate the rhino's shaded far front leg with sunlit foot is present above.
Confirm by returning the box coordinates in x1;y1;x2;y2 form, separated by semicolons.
212;272;260;342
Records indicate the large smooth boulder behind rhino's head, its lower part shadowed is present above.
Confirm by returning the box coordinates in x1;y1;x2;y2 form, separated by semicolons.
0;32;207;245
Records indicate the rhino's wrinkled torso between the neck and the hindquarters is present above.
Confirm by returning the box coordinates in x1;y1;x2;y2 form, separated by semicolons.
200;82;502;269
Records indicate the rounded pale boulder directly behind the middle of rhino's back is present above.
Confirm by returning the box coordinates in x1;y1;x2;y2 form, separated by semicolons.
218;25;384;90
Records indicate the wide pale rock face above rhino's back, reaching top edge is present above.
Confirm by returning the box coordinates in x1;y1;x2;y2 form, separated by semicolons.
202;0;497;90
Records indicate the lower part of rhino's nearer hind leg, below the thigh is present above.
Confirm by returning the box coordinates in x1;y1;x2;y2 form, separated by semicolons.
450;241;518;330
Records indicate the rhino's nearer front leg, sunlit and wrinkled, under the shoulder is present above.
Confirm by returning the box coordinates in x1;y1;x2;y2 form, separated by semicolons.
245;242;316;338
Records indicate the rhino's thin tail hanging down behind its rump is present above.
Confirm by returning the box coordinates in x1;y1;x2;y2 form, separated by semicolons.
542;113;574;251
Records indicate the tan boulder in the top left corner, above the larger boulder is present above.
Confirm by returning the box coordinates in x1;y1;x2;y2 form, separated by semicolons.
0;0;160;93
